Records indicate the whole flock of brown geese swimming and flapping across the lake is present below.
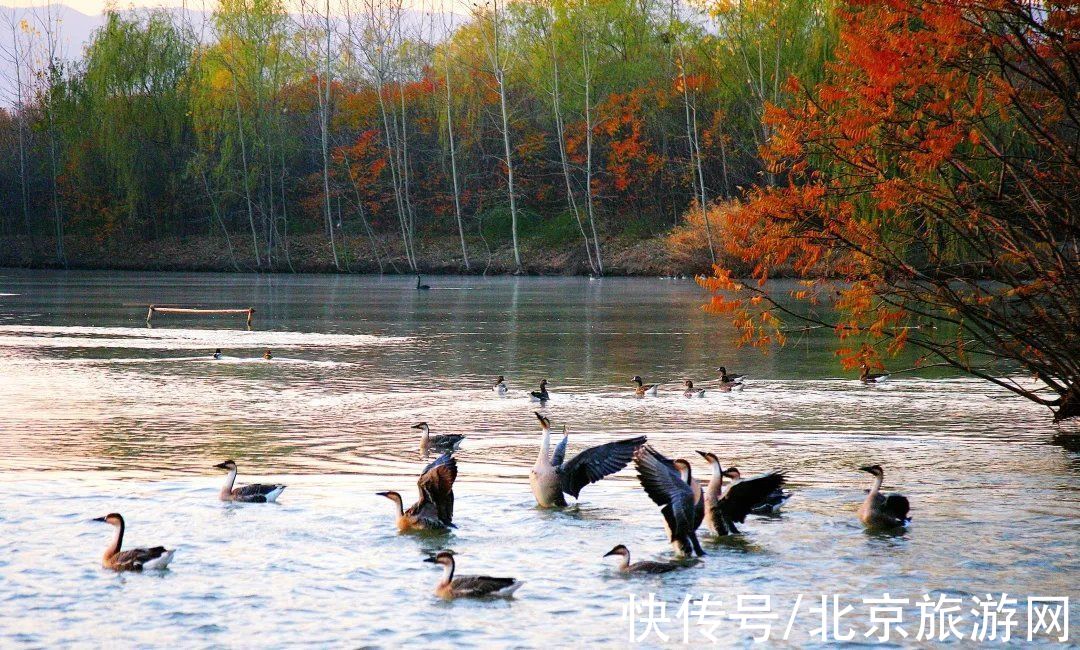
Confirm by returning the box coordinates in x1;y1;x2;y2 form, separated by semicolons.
94;349;910;599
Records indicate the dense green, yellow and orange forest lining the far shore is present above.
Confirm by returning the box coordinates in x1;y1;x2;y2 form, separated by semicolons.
0;0;837;274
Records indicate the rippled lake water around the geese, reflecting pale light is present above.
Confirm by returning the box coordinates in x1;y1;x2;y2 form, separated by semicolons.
0;270;1080;648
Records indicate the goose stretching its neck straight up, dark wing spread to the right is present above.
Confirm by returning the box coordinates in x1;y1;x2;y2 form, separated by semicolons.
529;412;646;507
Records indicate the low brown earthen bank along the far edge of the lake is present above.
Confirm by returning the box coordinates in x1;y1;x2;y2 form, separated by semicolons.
0;229;707;276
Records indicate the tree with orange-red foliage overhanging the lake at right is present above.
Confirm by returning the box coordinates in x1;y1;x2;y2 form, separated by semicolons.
700;0;1080;420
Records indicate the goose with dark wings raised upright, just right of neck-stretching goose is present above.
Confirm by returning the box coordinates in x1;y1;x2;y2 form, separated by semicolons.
634;445;705;555
